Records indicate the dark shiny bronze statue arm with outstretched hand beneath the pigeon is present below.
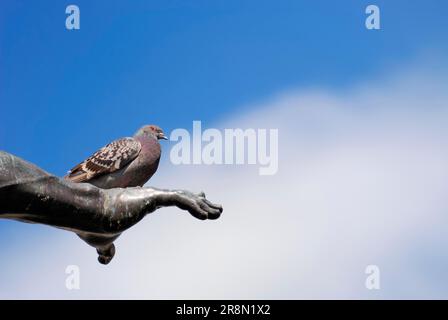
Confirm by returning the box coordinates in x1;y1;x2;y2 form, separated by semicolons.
0;151;222;264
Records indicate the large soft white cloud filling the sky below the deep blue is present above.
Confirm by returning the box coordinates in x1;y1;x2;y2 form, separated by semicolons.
0;61;448;299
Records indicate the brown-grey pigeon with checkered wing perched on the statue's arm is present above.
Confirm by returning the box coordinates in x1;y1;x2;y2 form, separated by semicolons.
64;125;168;189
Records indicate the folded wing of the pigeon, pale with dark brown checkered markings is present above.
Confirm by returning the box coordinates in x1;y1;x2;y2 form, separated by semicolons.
64;138;142;182
